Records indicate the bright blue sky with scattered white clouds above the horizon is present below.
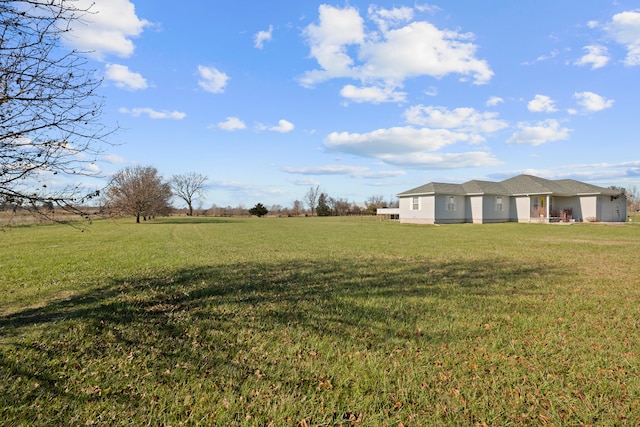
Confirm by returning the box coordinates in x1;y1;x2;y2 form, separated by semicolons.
67;0;640;211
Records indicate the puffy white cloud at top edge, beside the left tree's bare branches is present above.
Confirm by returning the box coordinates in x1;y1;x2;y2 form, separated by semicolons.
65;0;151;60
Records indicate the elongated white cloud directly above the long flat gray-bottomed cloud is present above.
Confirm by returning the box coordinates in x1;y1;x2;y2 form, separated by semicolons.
404;105;507;133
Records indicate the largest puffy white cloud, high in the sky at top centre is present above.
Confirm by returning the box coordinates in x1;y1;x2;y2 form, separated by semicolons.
300;5;493;102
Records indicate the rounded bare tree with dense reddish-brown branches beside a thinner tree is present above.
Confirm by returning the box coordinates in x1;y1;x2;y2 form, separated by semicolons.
105;166;172;223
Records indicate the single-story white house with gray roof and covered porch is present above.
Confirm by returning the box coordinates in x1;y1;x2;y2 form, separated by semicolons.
389;175;627;224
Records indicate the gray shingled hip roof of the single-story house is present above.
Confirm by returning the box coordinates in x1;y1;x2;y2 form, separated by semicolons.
398;175;619;197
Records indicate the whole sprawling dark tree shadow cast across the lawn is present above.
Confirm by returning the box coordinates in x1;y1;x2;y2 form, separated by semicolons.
0;258;559;422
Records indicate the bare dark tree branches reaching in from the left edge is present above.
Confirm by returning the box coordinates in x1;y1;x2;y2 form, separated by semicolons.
0;0;110;214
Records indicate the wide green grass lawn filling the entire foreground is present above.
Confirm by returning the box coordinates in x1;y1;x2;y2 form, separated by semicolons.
0;218;640;426
